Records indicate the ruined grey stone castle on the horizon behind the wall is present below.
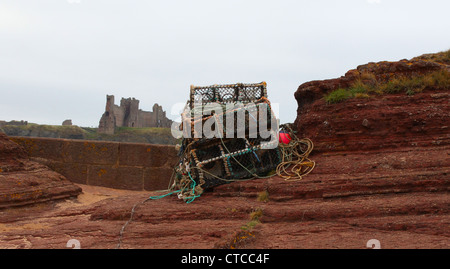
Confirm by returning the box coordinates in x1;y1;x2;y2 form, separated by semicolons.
98;95;172;134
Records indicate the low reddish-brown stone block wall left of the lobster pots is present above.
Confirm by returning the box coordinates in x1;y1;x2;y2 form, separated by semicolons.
10;137;178;191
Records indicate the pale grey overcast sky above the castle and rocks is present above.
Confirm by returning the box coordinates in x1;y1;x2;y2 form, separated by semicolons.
0;0;450;127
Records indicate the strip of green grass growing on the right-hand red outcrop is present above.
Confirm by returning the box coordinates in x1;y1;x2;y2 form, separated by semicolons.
325;69;450;104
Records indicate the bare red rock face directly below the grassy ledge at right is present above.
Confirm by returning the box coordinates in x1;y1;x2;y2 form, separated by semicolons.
296;91;450;152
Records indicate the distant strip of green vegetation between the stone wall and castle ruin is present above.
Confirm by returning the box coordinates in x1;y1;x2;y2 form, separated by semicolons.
0;123;179;145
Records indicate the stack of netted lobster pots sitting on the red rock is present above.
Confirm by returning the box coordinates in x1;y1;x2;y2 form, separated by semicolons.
172;82;281;202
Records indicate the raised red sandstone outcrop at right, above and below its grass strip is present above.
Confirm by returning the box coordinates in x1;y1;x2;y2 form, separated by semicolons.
295;52;450;152
